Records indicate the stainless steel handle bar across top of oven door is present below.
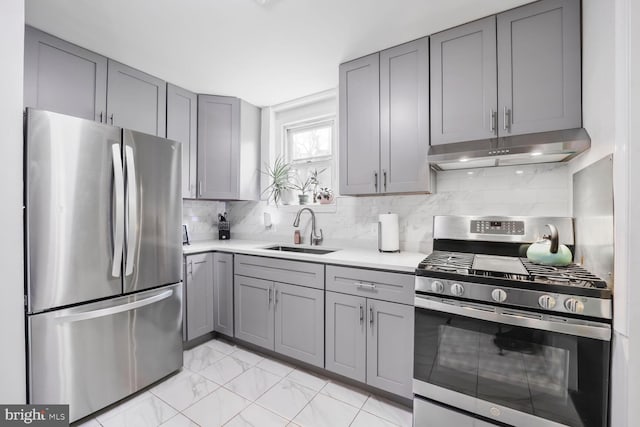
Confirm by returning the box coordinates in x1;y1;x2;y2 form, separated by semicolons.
415;296;611;341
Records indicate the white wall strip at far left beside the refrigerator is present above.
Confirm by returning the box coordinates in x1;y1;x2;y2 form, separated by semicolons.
0;0;26;403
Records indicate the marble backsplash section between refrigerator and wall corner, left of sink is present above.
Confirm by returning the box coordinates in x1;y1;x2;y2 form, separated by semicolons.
182;199;226;241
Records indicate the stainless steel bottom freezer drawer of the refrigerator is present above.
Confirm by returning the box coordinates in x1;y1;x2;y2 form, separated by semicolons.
28;283;182;421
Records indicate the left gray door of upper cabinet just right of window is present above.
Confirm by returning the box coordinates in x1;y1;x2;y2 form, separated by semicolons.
339;53;380;194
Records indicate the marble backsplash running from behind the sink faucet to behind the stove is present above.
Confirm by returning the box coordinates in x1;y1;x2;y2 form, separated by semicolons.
225;163;571;253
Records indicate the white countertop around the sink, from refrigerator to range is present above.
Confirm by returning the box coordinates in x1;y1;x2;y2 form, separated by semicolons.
183;240;427;273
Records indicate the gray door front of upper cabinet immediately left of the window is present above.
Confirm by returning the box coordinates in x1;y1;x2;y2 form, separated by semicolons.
198;95;240;199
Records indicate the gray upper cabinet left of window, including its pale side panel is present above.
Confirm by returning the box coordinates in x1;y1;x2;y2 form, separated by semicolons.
197;95;260;200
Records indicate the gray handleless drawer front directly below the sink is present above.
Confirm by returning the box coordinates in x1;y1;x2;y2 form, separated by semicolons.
235;255;324;289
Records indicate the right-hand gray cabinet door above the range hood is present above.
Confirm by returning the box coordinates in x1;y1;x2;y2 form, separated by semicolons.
498;0;582;136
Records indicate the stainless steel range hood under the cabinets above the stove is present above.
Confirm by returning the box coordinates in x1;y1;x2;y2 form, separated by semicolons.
428;128;591;170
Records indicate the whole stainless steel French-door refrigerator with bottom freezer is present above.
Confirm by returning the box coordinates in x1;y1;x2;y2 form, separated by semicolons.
25;109;182;421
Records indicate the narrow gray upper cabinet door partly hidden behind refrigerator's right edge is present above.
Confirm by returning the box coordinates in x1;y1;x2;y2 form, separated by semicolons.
167;84;198;199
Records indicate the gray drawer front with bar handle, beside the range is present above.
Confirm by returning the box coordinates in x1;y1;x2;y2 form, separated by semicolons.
327;265;415;305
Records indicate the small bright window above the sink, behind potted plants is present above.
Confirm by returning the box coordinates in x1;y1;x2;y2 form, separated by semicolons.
284;118;335;197
